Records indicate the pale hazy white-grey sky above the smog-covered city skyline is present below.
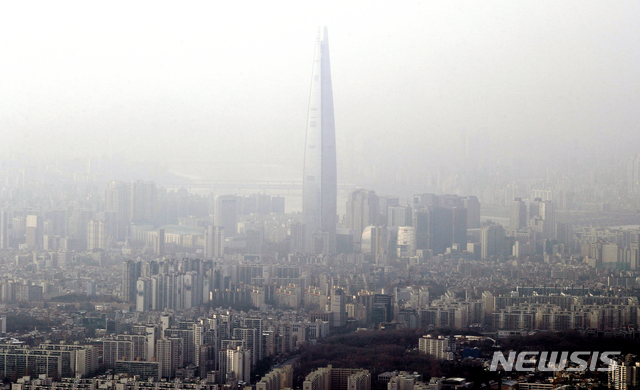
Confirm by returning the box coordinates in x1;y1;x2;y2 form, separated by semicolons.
0;0;640;181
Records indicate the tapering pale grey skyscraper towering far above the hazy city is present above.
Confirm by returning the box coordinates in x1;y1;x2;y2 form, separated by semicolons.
302;27;337;253
